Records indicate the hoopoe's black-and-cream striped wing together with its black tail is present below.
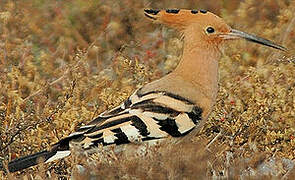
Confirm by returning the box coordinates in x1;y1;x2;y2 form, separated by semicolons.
8;89;202;172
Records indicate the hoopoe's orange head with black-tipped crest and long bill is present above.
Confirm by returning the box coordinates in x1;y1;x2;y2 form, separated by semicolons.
144;9;286;51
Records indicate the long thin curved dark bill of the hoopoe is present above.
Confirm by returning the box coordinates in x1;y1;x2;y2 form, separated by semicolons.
223;29;287;51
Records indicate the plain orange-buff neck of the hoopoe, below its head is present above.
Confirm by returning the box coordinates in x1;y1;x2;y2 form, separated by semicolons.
174;41;221;102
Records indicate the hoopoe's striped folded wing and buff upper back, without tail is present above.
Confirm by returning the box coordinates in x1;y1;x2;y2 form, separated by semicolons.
66;76;203;149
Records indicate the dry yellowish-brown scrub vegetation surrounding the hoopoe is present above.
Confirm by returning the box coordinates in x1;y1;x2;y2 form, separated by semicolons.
0;0;295;179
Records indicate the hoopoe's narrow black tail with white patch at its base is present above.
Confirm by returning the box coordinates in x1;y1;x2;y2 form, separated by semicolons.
8;146;71;172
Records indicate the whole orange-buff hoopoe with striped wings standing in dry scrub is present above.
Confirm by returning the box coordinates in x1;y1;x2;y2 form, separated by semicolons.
8;9;286;172
